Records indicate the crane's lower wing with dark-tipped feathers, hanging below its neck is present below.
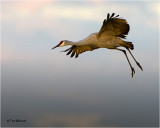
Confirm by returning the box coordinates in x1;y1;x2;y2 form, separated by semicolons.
62;45;97;58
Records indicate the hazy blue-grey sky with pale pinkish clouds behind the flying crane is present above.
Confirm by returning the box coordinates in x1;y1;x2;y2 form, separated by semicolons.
1;1;160;127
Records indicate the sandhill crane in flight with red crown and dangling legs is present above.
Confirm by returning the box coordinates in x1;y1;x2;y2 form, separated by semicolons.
52;13;143;77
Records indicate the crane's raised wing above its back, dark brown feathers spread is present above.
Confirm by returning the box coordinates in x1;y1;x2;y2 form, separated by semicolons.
97;13;129;38
